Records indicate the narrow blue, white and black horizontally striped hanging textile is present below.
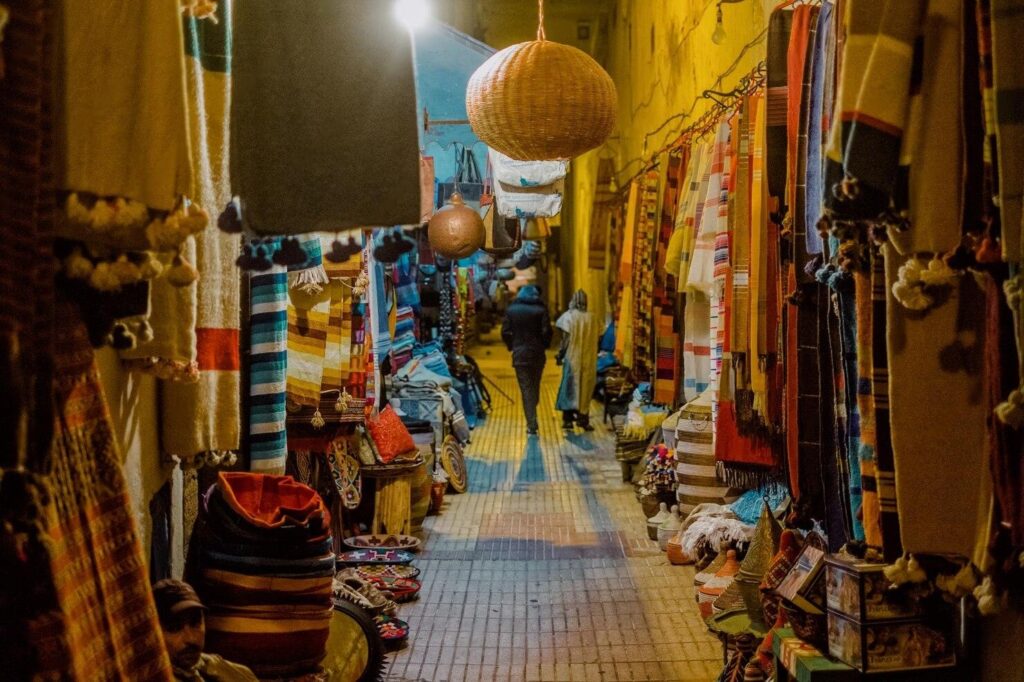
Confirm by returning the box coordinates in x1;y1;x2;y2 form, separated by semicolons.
249;250;288;475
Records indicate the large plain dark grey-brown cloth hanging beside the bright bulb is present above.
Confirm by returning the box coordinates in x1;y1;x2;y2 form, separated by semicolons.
231;0;420;235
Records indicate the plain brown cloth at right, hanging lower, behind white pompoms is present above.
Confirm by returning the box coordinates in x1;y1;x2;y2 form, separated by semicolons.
883;246;991;557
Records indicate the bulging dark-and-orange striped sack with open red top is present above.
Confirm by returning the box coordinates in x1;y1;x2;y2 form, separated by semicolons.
196;472;335;678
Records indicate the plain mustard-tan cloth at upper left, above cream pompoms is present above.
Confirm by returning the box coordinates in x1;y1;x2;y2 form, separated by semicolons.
55;0;193;211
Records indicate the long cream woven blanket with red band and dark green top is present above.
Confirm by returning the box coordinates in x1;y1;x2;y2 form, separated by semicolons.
163;3;241;457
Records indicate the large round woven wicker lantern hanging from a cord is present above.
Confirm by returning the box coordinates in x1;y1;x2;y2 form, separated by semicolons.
466;0;617;161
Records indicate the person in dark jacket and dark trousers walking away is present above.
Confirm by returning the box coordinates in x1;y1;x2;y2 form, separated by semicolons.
502;285;552;435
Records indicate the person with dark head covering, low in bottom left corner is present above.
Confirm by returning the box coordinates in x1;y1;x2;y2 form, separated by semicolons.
153;580;258;682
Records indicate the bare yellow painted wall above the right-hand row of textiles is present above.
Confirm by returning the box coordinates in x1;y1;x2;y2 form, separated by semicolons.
566;0;776;313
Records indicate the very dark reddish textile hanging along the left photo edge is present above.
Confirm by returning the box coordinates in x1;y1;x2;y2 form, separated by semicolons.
0;0;55;468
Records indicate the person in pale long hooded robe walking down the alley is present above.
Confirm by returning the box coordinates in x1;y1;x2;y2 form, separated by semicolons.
555;289;601;431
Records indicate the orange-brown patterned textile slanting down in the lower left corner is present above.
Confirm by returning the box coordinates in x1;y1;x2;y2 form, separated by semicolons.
20;303;171;681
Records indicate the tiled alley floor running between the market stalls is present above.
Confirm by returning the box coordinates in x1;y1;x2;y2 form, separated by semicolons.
387;337;722;682
